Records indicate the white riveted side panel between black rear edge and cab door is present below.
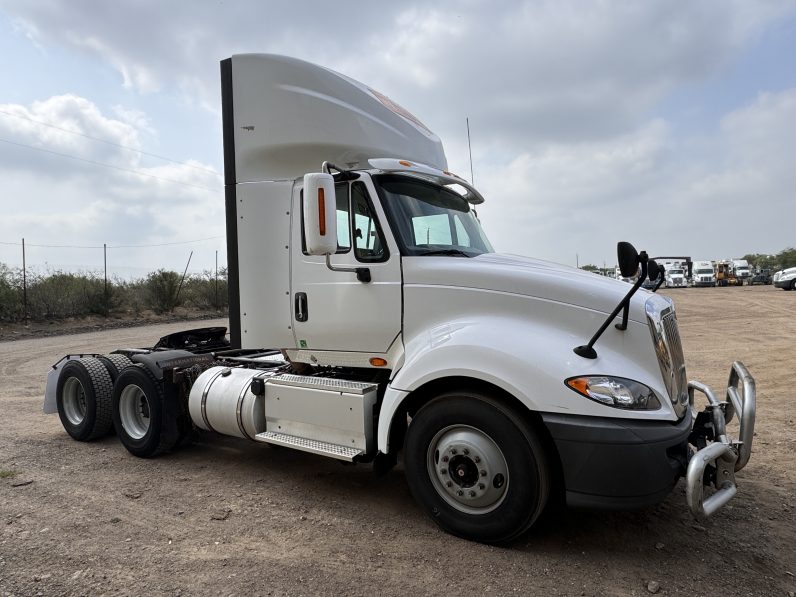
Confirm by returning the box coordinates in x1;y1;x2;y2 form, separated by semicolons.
237;180;295;348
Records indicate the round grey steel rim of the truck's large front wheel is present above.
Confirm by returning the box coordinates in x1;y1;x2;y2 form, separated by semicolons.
426;425;509;514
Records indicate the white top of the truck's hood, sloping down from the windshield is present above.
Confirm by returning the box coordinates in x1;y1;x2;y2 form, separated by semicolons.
403;253;651;323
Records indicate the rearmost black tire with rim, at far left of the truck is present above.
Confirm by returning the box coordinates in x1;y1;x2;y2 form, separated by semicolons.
56;357;113;442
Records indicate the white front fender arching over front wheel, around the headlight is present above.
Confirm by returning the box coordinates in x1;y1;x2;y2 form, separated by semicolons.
378;309;676;452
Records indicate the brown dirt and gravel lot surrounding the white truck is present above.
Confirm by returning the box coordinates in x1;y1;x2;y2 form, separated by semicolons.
0;286;796;597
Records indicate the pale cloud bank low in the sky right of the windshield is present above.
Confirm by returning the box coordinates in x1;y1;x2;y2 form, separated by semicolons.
480;88;796;263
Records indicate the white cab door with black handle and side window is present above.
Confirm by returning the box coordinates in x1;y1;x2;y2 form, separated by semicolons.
291;176;402;354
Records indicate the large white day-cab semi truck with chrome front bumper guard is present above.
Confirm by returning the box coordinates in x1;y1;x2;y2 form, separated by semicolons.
45;54;755;543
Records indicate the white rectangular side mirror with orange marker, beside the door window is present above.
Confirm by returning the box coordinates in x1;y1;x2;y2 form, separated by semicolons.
302;172;337;255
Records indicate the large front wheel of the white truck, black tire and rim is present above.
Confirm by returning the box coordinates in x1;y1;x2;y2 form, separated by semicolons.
404;392;550;543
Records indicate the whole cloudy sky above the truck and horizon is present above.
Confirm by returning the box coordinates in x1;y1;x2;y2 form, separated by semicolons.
0;0;796;276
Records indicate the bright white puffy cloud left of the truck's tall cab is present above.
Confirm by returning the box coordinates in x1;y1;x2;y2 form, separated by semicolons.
0;95;224;267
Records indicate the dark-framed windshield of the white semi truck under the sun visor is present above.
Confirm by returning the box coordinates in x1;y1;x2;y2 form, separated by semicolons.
373;174;494;257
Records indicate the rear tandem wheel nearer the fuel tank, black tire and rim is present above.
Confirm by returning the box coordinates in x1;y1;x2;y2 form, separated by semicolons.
111;363;180;458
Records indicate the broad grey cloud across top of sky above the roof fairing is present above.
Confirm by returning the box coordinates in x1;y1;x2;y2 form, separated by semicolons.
5;0;789;145
